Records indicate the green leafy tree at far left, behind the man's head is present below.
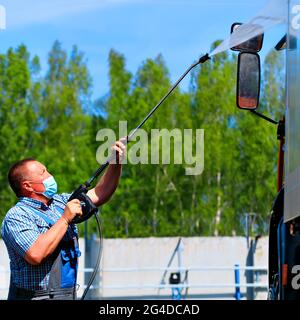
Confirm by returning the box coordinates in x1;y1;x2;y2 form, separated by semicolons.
0;45;37;217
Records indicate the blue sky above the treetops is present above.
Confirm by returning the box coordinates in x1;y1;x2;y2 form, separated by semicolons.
0;0;283;98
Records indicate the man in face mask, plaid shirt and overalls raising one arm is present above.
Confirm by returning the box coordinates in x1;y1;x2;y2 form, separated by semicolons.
1;139;125;300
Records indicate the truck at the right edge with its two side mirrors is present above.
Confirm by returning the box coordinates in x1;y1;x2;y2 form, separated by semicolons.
231;0;300;300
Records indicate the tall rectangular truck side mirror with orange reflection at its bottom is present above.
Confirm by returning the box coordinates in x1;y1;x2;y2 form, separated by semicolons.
236;52;260;110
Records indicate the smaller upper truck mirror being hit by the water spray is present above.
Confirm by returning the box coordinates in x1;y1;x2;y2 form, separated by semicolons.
231;22;264;52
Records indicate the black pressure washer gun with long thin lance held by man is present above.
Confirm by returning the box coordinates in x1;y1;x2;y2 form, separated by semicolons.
69;53;210;224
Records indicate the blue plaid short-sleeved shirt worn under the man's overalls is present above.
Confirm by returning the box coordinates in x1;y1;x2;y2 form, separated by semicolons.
1;193;78;290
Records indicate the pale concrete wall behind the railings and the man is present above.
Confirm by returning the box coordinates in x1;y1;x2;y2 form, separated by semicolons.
0;237;268;299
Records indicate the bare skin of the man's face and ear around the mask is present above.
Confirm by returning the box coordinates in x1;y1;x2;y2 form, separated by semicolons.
23;161;51;192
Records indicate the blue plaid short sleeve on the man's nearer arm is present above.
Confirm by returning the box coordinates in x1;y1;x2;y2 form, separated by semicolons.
2;213;40;257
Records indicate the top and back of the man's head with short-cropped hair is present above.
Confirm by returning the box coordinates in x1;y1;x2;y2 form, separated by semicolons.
8;158;46;197
